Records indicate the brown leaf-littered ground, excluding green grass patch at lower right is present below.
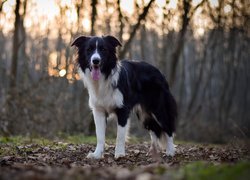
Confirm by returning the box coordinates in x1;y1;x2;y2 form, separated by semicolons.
0;142;250;180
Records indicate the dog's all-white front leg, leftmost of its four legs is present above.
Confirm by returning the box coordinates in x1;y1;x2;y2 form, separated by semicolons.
87;108;106;159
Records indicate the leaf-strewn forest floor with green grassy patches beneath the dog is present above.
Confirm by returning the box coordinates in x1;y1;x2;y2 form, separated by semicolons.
0;137;250;180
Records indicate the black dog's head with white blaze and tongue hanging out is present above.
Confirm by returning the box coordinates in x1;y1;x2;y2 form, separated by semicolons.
72;36;121;80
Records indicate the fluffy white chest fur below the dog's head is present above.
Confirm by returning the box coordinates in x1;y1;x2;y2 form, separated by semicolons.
80;69;123;113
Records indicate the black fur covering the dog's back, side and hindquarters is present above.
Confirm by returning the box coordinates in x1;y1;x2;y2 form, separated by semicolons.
117;60;177;137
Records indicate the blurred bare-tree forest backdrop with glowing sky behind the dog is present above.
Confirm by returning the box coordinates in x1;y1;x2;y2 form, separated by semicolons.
0;0;250;142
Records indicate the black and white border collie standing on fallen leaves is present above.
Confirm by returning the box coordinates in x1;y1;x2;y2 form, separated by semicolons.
72;36;177;159
